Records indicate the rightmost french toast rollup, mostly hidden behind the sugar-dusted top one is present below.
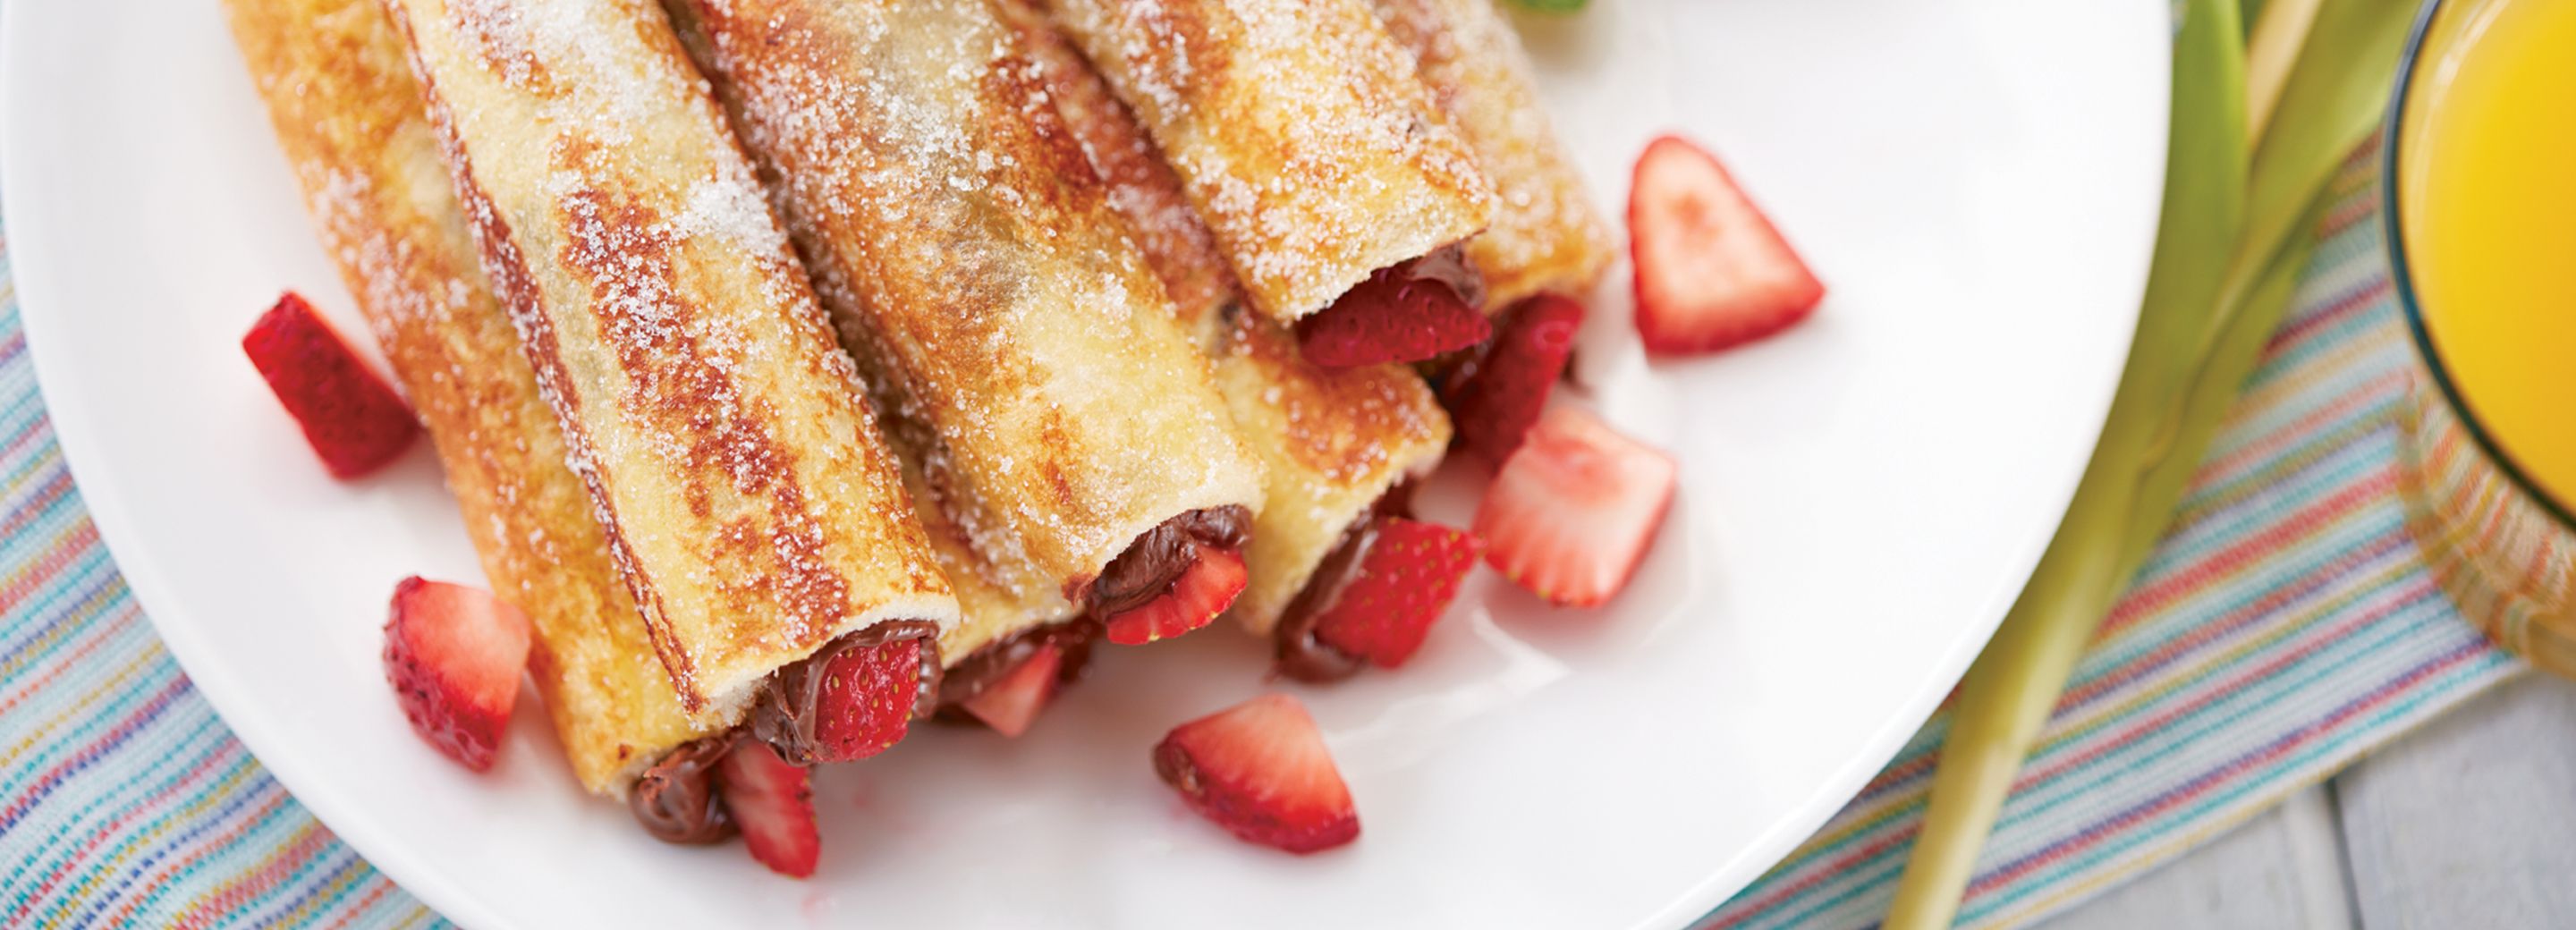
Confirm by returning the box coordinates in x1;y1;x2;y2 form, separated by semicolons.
1373;0;1618;314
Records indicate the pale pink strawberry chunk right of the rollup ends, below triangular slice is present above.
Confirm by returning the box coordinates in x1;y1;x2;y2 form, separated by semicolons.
1476;404;1674;605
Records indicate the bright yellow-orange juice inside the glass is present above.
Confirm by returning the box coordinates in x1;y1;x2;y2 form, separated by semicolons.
2395;0;2576;510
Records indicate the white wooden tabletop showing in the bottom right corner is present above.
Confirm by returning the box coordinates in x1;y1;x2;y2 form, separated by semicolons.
2043;672;2576;930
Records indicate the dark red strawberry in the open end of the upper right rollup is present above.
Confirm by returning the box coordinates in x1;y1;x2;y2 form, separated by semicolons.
1296;266;1494;368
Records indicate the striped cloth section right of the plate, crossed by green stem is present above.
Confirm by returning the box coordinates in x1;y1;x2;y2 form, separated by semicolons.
1703;155;2520;930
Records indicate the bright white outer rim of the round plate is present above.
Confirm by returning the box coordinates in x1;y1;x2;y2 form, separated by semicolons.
0;0;2172;927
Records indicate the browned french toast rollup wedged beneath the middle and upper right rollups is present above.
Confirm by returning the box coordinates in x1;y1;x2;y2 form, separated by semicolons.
1002;0;1450;678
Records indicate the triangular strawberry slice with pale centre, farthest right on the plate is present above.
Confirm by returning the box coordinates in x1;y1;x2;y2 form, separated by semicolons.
1628;137;1824;353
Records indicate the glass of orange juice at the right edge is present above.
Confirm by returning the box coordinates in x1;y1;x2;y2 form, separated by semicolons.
2380;0;2576;675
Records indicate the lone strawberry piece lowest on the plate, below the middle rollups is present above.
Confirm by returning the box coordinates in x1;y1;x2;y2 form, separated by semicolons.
1154;693;1360;853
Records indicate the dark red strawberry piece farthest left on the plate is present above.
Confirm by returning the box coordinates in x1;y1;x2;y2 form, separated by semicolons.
242;293;419;479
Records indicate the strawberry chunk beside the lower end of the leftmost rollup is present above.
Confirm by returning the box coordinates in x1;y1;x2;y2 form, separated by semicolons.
384;577;528;773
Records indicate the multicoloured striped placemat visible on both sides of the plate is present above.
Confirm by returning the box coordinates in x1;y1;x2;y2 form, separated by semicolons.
0;147;2514;930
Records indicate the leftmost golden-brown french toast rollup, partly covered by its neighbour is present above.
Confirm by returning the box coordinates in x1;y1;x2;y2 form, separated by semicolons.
225;0;716;796
